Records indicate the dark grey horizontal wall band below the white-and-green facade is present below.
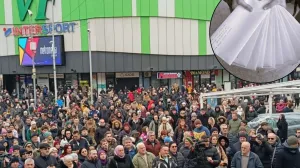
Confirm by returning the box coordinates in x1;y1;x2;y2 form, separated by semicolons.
0;52;222;74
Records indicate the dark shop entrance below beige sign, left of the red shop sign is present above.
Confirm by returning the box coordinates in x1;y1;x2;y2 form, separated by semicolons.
115;78;139;91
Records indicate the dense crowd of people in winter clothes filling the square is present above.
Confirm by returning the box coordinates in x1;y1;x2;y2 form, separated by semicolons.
0;85;300;168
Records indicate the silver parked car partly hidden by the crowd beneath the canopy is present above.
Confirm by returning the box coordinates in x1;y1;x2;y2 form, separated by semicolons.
248;112;300;136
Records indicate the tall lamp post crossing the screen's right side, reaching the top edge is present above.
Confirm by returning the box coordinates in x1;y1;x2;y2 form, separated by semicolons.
52;0;57;103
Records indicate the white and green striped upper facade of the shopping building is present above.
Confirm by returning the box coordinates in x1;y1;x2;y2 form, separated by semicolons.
0;0;219;56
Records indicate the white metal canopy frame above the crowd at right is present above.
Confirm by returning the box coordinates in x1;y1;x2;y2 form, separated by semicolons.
199;80;300;114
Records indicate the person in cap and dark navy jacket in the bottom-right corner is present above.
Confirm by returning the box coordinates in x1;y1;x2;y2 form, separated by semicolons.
274;136;300;168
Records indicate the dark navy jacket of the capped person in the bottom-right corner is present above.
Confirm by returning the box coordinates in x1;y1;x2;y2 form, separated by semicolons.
274;142;300;168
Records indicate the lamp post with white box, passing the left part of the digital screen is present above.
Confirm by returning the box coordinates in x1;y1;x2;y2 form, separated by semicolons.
28;10;37;107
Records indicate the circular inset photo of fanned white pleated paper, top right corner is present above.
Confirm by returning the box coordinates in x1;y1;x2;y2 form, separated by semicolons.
209;0;300;83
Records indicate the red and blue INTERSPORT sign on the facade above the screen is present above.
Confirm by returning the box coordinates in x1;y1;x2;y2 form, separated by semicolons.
3;22;76;37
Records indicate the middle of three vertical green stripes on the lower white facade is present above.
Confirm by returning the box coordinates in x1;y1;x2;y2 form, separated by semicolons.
141;17;150;54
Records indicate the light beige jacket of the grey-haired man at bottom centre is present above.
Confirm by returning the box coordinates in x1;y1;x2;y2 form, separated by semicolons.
132;152;155;168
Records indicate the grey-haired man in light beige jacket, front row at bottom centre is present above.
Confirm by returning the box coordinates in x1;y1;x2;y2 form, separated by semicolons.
132;143;155;168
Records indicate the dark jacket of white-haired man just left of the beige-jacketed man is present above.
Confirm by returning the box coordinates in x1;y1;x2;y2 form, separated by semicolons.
108;155;134;168
